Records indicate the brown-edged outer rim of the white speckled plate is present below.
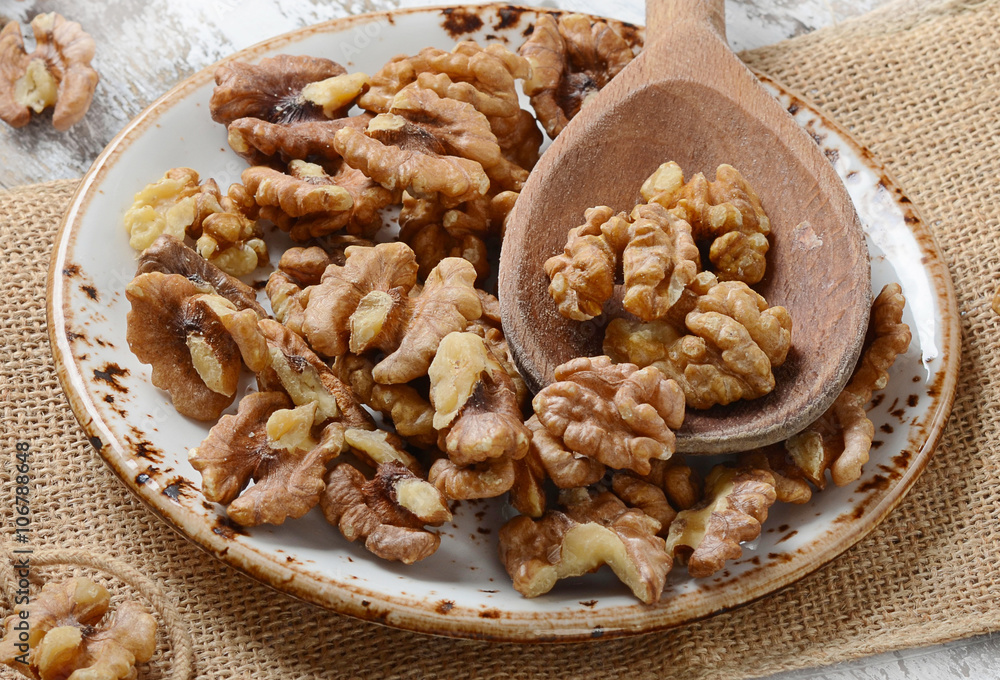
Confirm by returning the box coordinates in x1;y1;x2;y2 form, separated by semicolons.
46;3;961;643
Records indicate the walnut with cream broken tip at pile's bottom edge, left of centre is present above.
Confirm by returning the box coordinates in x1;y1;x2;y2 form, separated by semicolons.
320;462;452;564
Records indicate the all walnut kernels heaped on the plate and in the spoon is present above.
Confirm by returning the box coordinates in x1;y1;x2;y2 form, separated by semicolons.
126;15;909;603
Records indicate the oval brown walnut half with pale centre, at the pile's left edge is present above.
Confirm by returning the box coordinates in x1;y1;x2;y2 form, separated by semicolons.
125;272;241;420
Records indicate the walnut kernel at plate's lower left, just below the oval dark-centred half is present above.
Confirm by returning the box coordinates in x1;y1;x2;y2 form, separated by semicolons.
188;392;344;526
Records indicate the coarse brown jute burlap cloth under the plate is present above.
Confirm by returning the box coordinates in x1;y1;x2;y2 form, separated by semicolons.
0;1;1000;679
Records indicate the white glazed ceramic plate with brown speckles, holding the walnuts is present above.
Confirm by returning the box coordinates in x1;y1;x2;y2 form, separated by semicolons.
48;5;960;641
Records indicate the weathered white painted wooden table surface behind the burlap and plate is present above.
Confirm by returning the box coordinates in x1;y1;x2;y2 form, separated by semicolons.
0;0;1000;680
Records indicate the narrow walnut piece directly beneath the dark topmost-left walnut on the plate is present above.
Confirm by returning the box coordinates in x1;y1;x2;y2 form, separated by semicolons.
227;113;372;166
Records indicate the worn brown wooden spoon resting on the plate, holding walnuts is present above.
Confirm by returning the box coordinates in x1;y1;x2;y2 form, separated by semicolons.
499;0;871;453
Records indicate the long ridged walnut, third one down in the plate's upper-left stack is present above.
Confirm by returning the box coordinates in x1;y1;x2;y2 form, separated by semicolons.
242;160;394;241
